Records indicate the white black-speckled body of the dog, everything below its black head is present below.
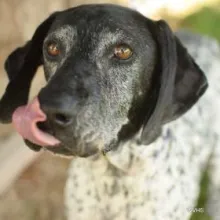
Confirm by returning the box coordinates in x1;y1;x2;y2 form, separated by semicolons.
65;32;220;220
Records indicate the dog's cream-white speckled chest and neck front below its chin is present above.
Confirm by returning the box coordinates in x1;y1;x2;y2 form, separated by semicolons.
66;102;216;220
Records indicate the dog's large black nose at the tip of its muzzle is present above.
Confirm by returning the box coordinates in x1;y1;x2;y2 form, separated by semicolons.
38;71;89;127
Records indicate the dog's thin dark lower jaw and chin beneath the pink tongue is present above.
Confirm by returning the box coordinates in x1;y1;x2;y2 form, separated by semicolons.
24;139;99;157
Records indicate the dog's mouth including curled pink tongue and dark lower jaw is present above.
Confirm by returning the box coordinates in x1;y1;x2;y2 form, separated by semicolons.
12;97;98;157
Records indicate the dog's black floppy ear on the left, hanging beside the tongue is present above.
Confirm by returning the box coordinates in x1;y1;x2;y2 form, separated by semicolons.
0;12;58;123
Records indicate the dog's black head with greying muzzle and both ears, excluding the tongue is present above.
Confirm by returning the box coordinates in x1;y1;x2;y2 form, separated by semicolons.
0;5;207;156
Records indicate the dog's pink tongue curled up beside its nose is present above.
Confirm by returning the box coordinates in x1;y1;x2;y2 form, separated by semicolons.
12;97;60;146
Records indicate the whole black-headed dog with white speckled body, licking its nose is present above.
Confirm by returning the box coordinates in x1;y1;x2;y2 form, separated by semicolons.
0;4;220;220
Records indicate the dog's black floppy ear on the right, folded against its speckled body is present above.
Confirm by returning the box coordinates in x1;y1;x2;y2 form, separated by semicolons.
141;20;208;144
